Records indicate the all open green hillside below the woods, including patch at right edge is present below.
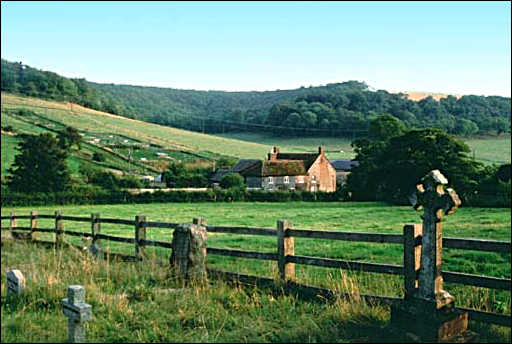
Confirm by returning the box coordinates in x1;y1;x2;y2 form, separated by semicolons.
1;93;510;183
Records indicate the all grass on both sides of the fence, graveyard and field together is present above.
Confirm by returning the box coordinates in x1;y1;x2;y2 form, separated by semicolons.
1;202;510;342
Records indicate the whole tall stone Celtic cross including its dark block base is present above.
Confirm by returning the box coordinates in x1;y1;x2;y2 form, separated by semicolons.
391;170;471;342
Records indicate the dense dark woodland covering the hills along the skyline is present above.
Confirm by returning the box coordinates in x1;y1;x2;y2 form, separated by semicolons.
1;59;511;137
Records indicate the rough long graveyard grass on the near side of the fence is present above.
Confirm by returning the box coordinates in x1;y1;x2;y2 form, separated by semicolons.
1;238;510;342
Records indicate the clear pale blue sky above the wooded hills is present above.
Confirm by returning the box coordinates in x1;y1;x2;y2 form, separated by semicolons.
1;1;511;97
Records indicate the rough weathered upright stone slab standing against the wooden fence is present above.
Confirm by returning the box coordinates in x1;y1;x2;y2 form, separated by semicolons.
170;218;206;282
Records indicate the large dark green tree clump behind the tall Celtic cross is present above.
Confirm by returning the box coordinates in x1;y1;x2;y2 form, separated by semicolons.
343;115;511;207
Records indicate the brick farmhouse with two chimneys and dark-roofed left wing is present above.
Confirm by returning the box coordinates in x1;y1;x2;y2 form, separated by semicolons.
220;146;336;192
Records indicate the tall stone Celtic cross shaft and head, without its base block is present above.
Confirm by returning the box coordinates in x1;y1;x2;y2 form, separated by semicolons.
410;170;461;309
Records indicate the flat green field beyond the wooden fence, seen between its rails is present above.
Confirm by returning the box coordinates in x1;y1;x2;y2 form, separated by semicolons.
2;202;511;313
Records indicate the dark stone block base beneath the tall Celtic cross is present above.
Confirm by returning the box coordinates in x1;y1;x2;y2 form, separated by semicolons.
390;302;477;343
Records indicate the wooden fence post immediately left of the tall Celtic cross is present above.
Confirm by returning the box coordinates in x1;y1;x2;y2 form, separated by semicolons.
403;224;423;300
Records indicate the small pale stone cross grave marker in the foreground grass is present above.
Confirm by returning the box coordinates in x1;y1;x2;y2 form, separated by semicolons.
62;285;92;343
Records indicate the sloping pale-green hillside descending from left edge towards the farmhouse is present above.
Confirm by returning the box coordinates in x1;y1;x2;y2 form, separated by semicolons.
1;93;276;180
